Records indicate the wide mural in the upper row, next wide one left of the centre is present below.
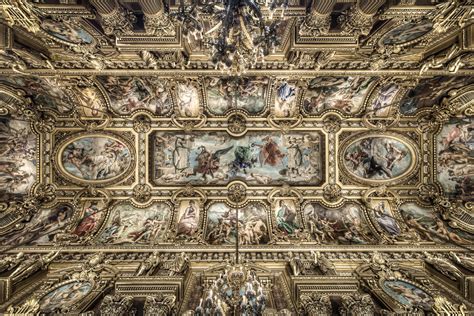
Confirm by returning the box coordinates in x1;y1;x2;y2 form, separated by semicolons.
98;76;173;115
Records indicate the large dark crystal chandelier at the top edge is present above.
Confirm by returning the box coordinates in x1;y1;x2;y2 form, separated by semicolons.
170;0;289;74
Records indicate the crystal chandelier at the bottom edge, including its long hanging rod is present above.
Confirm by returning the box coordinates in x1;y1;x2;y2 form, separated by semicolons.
194;209;267;316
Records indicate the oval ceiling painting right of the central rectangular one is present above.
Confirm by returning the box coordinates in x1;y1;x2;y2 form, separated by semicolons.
343;136;414;180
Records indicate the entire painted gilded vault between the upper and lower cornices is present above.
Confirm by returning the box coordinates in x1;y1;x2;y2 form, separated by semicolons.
0;74;474;249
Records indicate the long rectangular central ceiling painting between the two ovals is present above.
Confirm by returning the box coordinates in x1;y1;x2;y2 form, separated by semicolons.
151;132;324;185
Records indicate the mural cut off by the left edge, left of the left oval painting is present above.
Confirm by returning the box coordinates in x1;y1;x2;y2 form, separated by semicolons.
0;116;37;196
